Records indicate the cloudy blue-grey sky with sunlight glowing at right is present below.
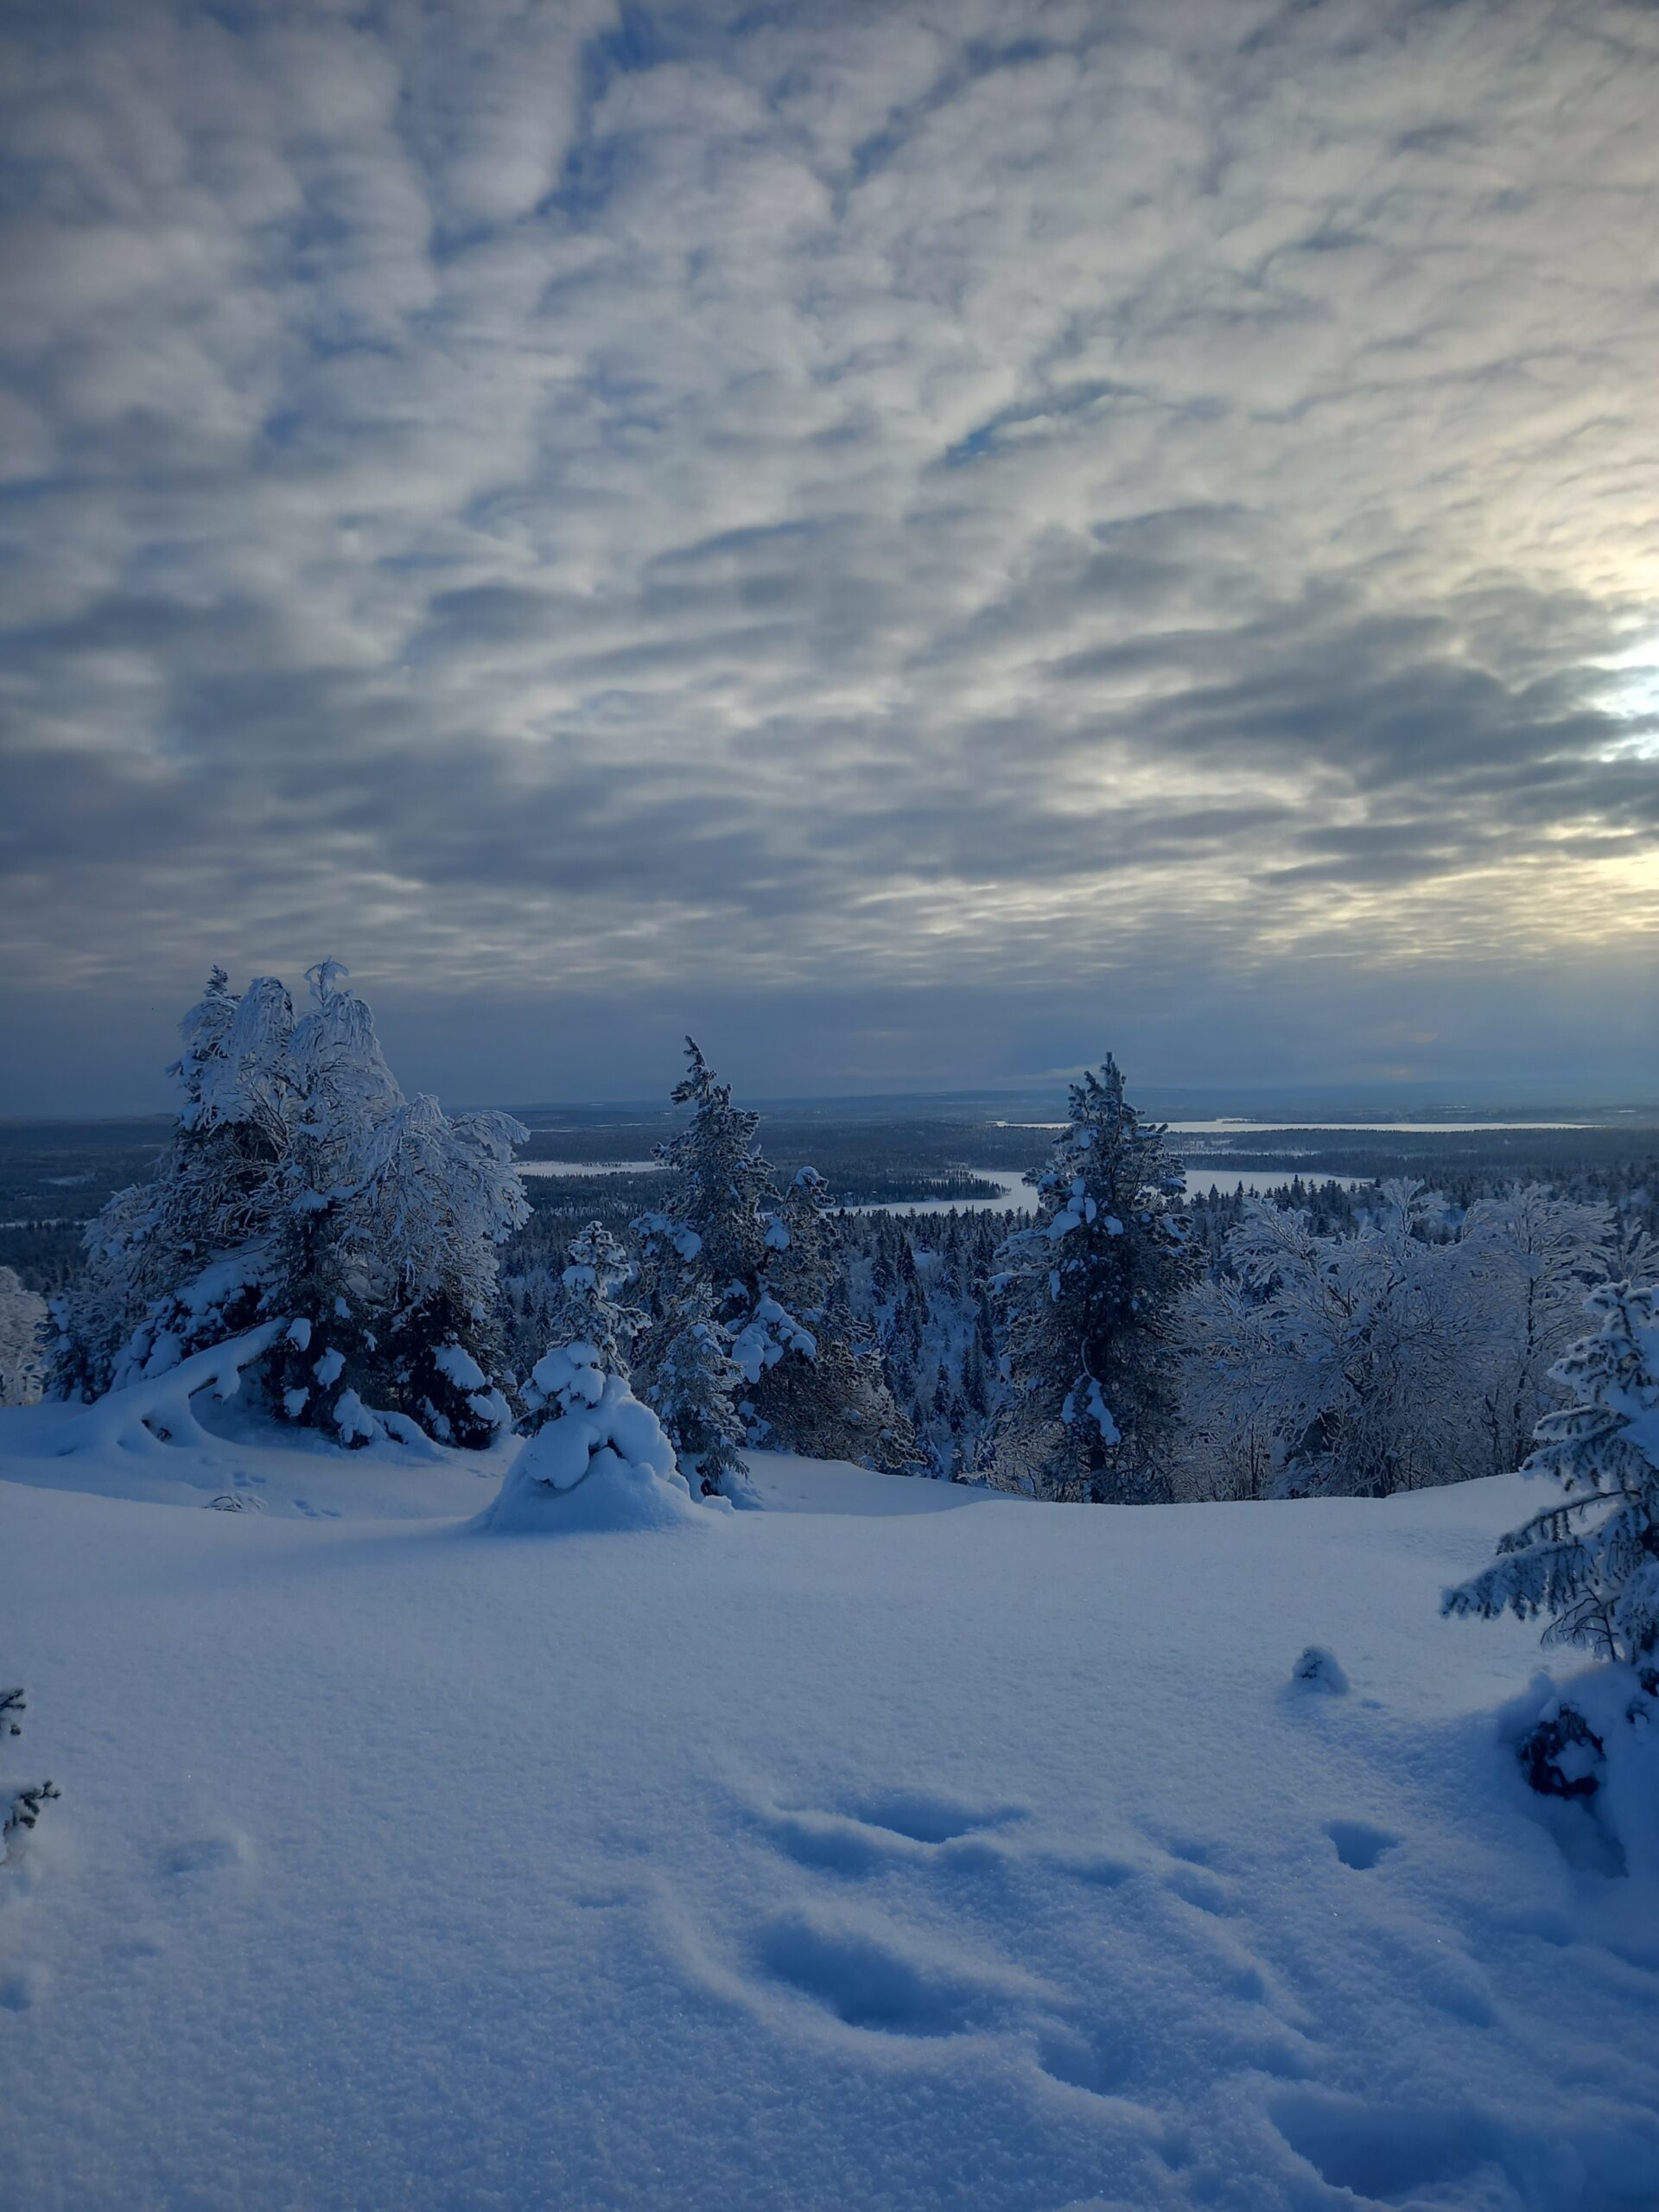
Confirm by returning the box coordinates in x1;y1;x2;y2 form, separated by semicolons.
0;0;1659;1115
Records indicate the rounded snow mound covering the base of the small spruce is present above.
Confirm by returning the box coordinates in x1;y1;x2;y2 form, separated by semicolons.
474;1363;706;1535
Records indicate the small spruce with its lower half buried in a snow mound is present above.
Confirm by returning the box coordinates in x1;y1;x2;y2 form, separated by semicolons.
480;1221;695;1535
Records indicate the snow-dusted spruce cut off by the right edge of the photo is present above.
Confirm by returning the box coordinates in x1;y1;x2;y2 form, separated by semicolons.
1442;1283;1659;1666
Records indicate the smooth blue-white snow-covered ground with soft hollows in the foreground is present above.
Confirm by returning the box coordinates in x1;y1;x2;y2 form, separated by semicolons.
0;1409;1659;2212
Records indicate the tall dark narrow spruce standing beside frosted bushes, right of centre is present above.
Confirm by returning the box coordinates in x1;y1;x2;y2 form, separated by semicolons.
993;1055;1197;1504
